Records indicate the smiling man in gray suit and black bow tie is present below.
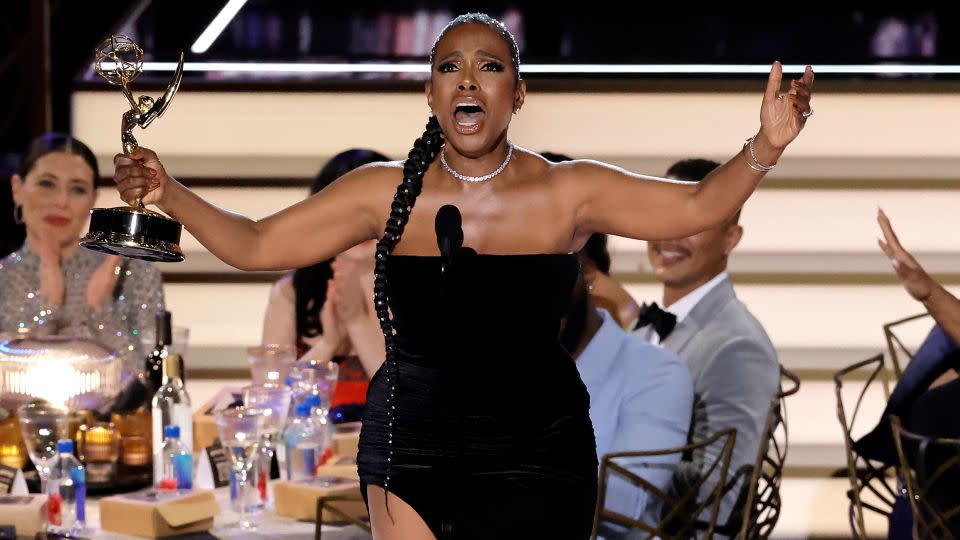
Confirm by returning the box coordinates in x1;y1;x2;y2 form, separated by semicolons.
636;159;780;524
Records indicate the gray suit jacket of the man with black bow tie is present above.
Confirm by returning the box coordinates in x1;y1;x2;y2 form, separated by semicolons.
636;279;780;523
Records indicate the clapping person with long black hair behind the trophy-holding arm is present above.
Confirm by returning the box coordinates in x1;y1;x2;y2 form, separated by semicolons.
263;149;388;407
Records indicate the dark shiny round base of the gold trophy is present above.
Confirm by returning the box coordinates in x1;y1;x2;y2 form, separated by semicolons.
80;207;183;262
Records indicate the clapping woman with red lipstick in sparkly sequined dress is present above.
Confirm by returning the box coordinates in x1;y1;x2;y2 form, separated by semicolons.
0;133;164;373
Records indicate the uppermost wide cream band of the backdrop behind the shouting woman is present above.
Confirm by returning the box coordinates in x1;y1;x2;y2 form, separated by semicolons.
73;90;960;176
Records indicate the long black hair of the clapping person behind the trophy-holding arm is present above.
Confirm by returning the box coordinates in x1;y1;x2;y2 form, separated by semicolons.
293;148;389;342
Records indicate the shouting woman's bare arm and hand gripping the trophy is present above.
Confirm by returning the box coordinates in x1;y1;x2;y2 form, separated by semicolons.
114;147;402;270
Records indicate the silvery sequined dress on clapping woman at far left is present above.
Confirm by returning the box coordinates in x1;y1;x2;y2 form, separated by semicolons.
0;243;164;373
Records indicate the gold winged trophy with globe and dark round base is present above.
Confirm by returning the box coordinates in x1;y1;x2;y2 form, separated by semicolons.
80;35;183;262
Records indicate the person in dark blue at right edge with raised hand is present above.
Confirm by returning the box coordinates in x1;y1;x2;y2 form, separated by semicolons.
854;210;960;538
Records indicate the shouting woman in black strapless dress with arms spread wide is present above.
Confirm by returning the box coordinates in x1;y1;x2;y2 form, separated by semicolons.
114;14;813;540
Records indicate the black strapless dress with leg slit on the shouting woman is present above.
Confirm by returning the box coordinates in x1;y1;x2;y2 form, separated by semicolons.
357;249;597;540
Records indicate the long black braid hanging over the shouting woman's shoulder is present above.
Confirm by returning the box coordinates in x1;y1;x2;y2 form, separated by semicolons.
373;116;443;511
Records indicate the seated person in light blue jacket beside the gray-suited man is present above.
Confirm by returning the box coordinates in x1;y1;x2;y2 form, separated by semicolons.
561;239;693;536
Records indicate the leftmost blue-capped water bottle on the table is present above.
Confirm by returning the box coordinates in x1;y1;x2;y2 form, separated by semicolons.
47;439;87;536
